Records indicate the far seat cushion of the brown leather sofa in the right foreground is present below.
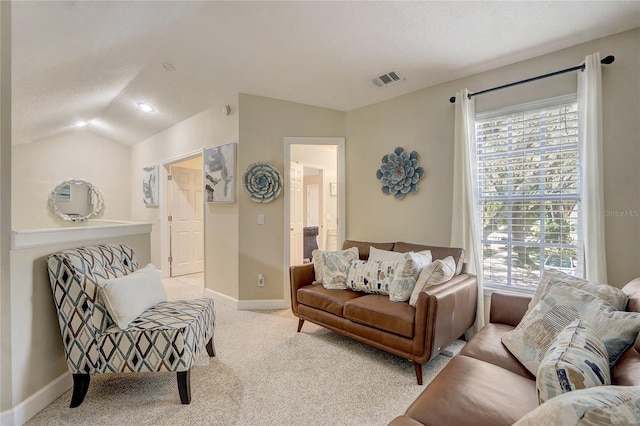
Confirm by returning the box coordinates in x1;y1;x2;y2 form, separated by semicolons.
460;323;535;380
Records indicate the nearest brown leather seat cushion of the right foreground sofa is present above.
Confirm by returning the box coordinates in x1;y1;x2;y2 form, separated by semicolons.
406;355;538;426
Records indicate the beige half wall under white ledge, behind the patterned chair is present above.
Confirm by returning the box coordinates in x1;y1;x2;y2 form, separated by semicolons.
8;234;150;415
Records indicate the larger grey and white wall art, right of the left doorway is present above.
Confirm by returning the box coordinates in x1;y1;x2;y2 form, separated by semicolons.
202;142;238;203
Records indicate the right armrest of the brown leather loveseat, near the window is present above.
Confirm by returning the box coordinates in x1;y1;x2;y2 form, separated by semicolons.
413;274;478;362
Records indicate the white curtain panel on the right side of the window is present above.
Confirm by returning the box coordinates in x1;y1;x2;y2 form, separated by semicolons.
578;52;607;284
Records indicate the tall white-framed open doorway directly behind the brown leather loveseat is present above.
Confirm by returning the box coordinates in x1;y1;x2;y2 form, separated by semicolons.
284;138;345;288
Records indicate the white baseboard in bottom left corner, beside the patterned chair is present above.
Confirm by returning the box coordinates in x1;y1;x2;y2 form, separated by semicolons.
0;372;73;426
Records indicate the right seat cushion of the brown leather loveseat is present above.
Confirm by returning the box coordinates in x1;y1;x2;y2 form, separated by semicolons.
344;294;416;338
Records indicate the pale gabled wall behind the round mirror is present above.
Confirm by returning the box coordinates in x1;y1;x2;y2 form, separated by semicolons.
11;128;132;229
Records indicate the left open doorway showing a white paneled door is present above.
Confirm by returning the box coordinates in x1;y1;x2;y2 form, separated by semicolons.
165;153;204;277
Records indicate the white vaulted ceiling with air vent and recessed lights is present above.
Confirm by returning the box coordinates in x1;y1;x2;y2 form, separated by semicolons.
12;1;640;145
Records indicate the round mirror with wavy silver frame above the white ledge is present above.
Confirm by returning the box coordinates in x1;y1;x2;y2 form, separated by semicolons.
49;179;104;222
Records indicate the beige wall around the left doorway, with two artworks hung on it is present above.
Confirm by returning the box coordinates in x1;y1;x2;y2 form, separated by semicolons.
130;105;239;299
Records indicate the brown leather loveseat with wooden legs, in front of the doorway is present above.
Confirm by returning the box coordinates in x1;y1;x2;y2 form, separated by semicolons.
289;240;477;384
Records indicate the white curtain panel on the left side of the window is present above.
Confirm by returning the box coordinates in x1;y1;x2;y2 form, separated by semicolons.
451;89;484;331
